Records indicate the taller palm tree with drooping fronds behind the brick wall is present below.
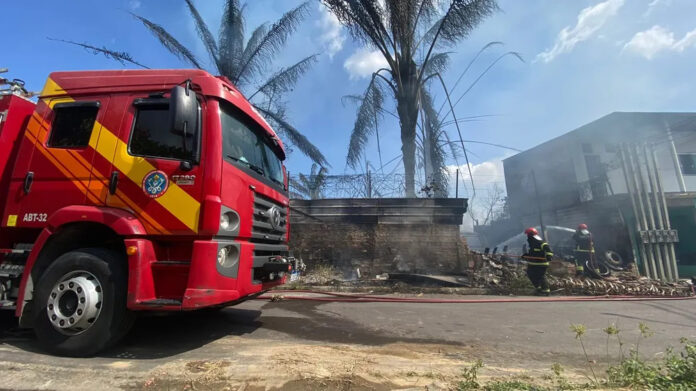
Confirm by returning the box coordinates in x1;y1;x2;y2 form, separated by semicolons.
322;0;498;197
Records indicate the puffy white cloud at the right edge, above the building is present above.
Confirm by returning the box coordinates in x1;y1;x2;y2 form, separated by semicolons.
624;25;696;60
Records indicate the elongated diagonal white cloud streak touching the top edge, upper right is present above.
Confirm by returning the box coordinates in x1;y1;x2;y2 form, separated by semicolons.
536;0;624;62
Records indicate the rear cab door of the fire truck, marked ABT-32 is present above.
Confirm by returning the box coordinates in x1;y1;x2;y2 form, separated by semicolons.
3;97;108;227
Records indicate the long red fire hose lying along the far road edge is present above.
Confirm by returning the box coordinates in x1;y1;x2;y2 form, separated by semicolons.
256;286;696;304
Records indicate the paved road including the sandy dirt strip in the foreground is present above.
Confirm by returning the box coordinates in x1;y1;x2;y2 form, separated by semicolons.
0;300;696;389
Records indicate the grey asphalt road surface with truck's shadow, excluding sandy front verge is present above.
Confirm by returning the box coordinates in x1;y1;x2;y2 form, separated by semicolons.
0;296;696;389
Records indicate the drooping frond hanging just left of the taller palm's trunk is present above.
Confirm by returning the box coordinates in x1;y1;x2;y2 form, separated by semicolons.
346;75;384;168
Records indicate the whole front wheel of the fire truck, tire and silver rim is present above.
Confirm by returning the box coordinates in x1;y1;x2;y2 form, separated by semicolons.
33;248;134;357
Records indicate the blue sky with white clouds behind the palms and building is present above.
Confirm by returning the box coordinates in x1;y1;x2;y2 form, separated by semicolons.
0;0;696;214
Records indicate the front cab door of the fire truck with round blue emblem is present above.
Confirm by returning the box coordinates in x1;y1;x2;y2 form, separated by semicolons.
102;96;204;235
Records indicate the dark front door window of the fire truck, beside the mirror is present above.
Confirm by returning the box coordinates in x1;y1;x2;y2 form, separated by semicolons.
130;99;199;161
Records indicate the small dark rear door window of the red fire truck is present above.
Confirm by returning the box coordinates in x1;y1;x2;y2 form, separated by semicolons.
48;102;99;148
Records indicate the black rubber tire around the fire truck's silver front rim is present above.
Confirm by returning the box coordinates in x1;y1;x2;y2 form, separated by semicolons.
33;248;135;357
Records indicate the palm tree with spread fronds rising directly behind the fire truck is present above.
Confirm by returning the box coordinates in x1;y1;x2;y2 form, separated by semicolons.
56;0;328;166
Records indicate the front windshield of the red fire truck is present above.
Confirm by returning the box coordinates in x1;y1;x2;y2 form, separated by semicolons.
220;102;283;184
